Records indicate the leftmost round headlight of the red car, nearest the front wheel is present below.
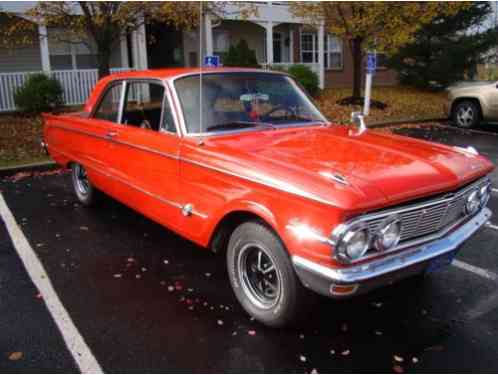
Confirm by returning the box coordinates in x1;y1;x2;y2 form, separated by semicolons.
334;222;370;262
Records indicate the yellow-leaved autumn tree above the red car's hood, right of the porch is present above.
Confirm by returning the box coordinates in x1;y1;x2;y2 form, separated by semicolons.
290;1;468;99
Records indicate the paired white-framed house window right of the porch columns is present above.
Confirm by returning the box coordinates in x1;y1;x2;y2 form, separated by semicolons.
301;33;344;69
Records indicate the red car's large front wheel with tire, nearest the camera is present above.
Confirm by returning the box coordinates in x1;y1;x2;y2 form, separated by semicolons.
227;222;308;327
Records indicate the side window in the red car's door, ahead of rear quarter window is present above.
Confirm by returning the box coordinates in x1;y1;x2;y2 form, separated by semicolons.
121;81;164;131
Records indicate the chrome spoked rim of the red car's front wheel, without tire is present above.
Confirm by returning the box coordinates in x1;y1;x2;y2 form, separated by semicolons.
237;243;281;309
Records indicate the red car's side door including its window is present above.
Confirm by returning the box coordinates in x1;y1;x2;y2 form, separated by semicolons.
110;79;182;229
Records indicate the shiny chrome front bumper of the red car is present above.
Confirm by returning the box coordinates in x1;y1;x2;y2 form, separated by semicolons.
292;208;491;284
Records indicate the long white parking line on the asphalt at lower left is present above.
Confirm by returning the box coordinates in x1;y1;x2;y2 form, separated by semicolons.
0;193;103;374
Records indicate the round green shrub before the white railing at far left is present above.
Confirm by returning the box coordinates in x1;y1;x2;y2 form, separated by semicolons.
14;73;62;113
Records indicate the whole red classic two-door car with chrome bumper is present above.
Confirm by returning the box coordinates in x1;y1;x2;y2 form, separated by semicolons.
44;68;493;326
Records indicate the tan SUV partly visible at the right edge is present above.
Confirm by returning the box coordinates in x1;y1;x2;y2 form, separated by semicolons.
448;81;498;129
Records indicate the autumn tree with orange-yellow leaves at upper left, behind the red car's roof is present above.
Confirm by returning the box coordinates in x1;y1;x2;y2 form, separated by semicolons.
0;1;251;77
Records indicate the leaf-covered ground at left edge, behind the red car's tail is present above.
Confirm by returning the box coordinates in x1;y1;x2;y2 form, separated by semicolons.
0;115;50;167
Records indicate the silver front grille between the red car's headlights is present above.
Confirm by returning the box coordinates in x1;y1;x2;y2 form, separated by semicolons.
365;178;489;243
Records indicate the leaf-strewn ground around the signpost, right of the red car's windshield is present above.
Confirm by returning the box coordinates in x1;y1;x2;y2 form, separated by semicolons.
317;87;447;124
